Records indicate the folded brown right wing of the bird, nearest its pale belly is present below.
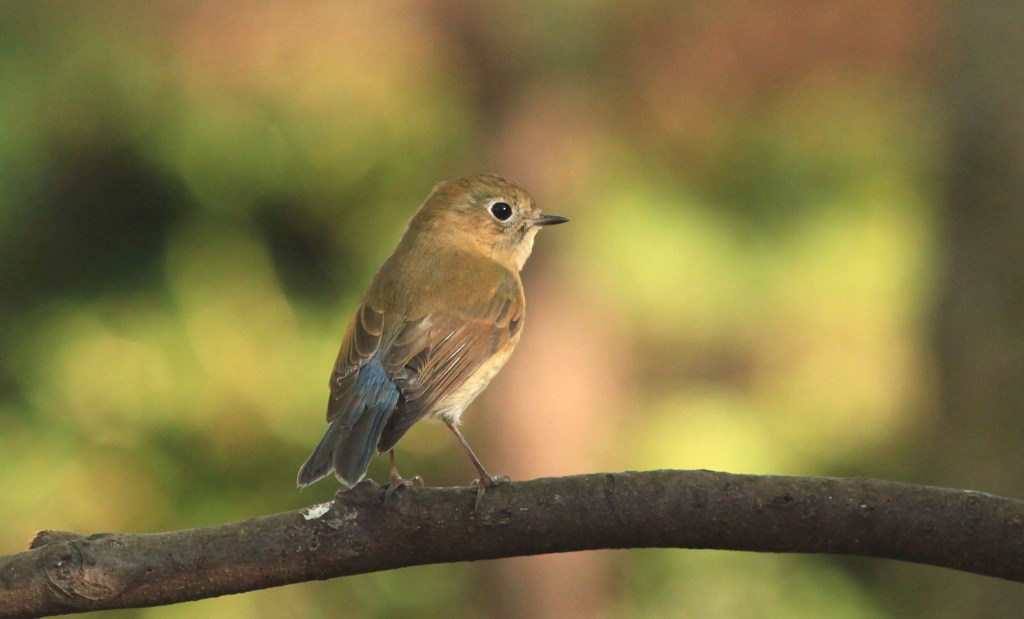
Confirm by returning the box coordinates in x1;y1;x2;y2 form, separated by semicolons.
377;279;523;451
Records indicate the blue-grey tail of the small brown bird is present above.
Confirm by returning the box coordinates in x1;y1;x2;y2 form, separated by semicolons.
296;364;398;488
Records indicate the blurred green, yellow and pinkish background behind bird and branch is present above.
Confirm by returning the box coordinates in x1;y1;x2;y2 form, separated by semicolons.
0;0;1024;619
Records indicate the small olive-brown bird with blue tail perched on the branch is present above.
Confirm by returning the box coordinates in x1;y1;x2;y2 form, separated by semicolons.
298;175;568;491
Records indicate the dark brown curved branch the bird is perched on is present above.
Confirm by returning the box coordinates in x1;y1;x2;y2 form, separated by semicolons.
0;470;1024;618
